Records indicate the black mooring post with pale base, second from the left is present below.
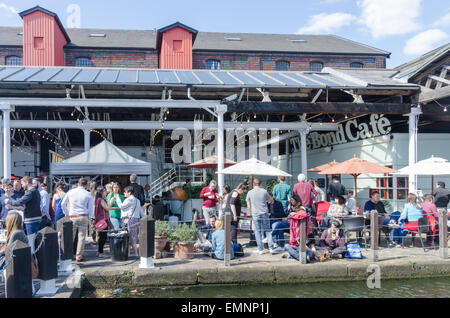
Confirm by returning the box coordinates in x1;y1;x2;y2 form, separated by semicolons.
35;226;59;296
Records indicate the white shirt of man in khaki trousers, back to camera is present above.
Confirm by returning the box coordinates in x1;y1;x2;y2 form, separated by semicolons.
61;187;94;218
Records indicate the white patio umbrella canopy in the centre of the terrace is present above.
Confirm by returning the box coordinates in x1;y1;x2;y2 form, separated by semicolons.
217;158;292;177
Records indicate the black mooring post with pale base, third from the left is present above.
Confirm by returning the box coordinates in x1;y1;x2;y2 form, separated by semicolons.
56;217;74;275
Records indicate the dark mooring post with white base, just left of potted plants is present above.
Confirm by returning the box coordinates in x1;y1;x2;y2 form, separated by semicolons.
139;215;155;268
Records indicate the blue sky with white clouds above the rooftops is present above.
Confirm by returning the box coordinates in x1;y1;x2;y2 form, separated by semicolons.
0;0;450;67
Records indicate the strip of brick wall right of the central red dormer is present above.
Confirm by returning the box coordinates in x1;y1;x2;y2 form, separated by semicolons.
193;51;386;71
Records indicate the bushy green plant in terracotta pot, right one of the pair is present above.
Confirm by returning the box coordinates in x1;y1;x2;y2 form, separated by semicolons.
172;223;197;259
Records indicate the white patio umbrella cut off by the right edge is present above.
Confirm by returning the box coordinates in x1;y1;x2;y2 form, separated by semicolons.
394;156;450;193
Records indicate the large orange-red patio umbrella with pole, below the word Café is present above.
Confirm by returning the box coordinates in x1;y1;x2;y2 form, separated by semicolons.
319;155;397;206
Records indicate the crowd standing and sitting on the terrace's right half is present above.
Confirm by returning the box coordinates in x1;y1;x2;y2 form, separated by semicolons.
194;174;450;260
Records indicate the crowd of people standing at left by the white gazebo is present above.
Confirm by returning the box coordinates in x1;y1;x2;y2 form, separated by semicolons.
0;174;149;262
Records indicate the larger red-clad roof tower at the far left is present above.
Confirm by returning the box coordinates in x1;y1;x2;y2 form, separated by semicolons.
19;6;70;66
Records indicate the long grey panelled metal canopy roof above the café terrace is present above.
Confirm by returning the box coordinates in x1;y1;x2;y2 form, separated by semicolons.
0;66;418;89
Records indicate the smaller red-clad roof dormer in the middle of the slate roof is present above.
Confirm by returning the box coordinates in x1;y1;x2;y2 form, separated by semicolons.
157;22;198;69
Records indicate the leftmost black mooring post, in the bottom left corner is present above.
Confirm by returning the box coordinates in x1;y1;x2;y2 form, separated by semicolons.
5;240;33;298
